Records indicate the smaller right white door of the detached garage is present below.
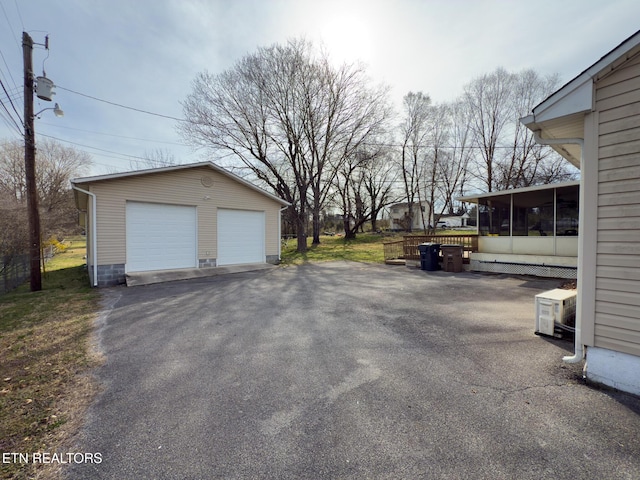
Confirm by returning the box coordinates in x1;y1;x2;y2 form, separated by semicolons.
217;209;265;265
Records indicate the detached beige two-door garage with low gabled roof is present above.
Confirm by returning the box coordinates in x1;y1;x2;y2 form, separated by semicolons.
71;162;289;286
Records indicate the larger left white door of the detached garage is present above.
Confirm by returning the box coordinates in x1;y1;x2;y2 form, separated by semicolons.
126;202;197;272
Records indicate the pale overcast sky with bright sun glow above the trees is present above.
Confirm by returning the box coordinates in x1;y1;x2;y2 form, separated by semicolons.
0;0;640;175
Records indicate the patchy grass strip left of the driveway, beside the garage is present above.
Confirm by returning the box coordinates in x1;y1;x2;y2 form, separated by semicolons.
0;237;99;479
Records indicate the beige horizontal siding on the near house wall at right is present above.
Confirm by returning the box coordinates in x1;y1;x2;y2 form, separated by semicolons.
594;58;640;355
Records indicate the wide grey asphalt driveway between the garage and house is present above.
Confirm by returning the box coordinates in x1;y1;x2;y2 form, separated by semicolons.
68;262;640;480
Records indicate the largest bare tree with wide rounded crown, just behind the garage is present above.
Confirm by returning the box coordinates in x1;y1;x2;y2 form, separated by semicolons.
179;40;388;251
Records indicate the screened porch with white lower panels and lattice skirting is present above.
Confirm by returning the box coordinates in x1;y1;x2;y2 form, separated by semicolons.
457;182;580;278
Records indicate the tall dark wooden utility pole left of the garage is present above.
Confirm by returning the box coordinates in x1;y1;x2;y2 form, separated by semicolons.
22;32;42;292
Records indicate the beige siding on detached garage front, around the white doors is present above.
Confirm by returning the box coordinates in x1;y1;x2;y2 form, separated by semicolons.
89;167;281;265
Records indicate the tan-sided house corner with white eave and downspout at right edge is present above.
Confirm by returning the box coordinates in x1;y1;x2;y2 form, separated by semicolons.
521;32;640;394
